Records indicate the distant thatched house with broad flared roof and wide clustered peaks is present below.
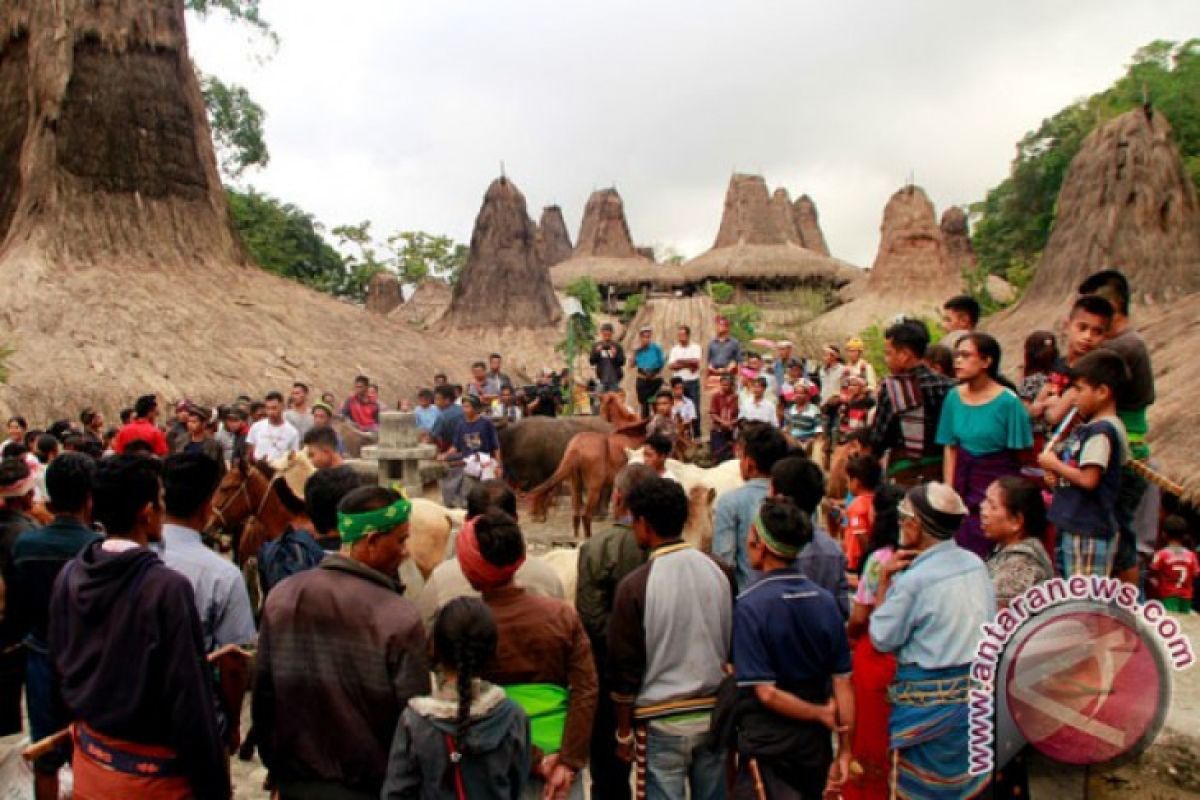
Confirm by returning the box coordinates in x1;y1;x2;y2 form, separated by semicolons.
682;174;860;305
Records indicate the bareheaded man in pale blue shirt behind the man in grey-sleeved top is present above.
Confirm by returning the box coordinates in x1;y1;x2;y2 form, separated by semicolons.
713;422;787;591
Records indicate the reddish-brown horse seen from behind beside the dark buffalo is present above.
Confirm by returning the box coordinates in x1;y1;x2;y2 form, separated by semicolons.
526;392;648;539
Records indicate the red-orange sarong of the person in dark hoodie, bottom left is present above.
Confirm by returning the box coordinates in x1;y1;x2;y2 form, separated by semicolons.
71;722;193;800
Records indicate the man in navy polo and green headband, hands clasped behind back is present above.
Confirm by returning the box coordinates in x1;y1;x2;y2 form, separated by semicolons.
733;498;854;800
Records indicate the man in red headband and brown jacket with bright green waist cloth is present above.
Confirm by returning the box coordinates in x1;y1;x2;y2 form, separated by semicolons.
458;509;596;800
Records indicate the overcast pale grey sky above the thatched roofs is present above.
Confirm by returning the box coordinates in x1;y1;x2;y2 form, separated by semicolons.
191;0;1200;266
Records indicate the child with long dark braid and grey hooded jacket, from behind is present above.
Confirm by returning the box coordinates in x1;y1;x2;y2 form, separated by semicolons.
383;597;532;800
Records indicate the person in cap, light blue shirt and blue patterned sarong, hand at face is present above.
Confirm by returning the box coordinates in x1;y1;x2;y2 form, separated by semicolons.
869;482;996;800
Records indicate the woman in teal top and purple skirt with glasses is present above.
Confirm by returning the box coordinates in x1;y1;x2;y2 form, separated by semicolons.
937;332;1033;559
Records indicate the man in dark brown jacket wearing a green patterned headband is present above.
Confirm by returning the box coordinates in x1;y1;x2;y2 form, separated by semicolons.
252;486;430;800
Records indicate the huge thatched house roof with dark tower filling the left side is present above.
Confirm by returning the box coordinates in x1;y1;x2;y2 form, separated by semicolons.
0;0;472;420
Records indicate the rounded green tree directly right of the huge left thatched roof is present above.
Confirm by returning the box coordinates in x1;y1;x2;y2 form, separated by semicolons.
226;188;349;294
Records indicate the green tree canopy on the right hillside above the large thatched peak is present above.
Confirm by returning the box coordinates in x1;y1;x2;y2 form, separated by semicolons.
971;40;1200;287
